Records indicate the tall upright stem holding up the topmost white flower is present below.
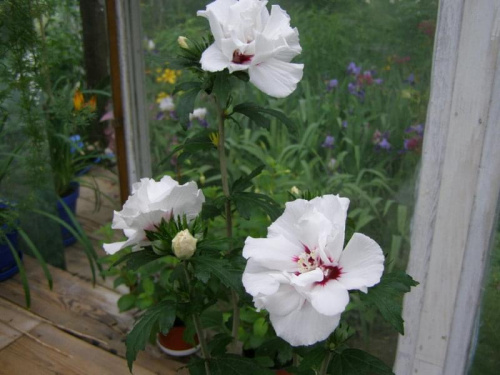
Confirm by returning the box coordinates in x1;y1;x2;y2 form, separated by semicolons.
215;98;240;353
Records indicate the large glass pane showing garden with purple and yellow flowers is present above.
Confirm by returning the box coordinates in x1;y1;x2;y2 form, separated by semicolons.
141;0;437;365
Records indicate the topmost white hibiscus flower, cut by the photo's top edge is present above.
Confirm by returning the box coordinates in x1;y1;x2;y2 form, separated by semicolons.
197;0;304;98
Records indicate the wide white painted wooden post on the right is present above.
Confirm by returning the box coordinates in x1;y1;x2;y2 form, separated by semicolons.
395;0;500;375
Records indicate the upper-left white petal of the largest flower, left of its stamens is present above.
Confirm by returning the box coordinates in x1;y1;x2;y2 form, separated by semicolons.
243;236;303;272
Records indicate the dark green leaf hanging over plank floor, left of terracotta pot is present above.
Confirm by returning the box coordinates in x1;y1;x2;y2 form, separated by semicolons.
125;300;175;371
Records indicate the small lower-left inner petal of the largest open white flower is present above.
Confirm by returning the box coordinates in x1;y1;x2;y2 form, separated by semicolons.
254;284;304;316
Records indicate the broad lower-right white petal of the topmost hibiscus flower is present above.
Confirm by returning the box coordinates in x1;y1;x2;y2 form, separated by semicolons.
248;58;304;98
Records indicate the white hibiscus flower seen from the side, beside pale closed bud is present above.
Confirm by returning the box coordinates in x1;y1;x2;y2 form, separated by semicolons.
103;176;205;254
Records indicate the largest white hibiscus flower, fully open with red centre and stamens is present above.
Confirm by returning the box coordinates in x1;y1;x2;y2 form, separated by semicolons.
243;195;384;346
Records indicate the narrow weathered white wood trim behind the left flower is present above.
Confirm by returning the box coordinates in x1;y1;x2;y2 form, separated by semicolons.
116;0;152;186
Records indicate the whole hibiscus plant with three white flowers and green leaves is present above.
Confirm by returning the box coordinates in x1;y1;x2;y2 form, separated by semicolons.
104;0;416;375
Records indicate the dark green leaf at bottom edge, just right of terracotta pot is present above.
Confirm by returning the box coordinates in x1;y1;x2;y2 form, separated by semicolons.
188;354;275;375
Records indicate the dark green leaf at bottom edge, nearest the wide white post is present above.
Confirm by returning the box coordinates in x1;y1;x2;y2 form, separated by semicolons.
328;349;394;375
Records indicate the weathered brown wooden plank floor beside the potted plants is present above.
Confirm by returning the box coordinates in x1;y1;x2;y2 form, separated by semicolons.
0;168;185;375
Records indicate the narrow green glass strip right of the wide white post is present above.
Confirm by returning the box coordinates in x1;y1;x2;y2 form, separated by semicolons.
470;227;500;375
